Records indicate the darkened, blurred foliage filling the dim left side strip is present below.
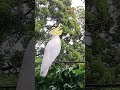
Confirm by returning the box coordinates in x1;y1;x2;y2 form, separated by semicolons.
0;0;35;87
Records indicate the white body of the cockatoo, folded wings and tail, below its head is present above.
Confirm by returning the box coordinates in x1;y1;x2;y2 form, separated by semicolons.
40;39;61;76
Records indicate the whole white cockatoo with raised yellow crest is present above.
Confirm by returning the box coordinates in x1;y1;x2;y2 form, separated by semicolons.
40;24;62;77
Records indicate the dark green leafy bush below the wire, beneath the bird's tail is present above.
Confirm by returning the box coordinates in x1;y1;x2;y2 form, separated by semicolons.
36;64;85;90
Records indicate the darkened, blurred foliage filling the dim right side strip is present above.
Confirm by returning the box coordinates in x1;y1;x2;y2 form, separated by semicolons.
85;0;120;85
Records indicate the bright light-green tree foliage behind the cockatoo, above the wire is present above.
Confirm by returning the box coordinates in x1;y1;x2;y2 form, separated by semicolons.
35;0;84;61
